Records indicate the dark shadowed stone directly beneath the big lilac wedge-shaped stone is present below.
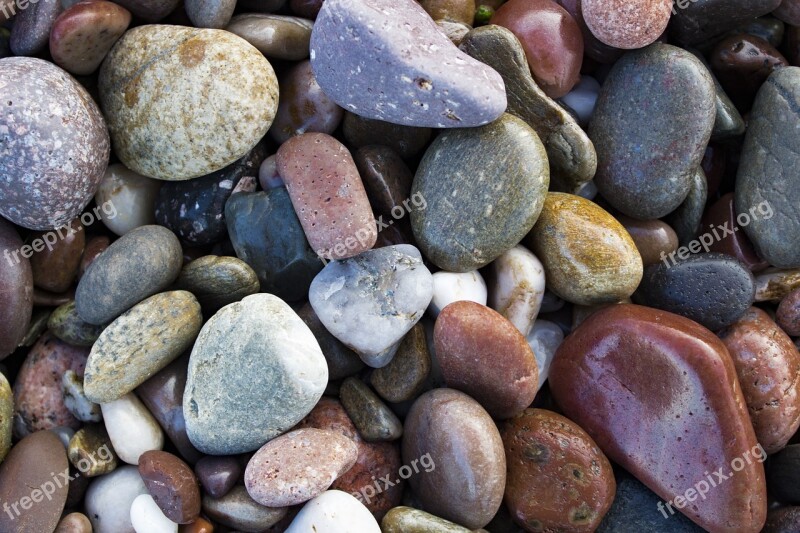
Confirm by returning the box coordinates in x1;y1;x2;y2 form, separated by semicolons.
342;113;432;159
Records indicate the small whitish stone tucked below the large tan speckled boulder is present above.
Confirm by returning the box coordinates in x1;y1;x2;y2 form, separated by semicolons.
95;164;164;235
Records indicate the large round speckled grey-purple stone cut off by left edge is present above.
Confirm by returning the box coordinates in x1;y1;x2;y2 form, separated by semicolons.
0;57;110;230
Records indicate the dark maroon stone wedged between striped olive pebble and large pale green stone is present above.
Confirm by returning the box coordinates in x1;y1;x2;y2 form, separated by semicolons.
136;353;202;463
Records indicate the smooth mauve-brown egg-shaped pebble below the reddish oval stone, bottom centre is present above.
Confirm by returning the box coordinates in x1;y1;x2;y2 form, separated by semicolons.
403;389;506;529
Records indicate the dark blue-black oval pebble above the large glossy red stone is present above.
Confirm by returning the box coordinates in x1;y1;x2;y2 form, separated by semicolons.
632;250;755;331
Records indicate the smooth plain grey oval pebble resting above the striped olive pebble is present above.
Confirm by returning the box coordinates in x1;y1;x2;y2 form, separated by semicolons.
75;226;183;325
